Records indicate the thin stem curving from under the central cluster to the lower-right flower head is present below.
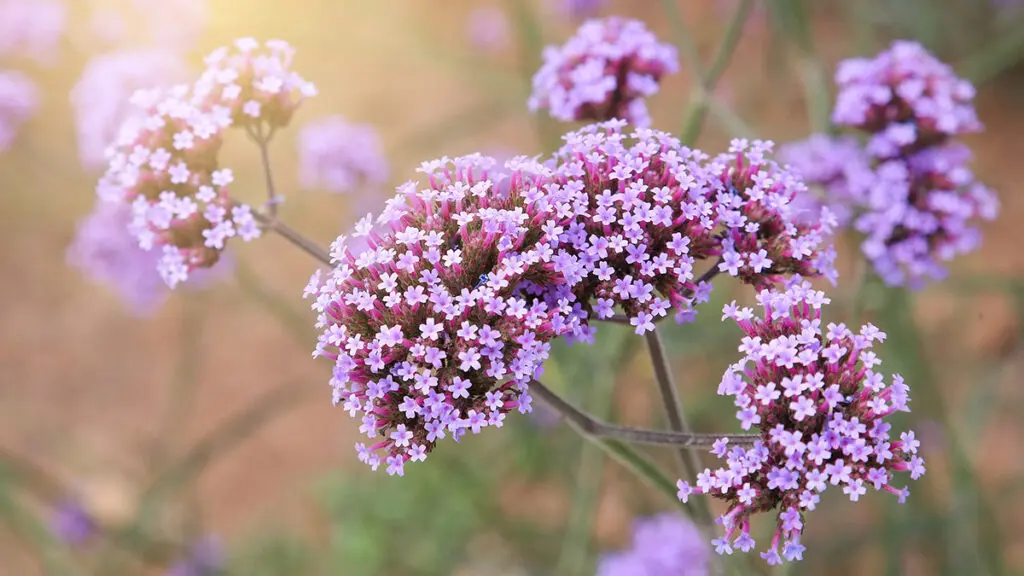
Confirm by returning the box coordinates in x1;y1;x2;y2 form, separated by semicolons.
529;380;761;449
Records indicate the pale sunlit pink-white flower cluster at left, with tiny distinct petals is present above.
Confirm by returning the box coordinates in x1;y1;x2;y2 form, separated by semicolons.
97;38;315;288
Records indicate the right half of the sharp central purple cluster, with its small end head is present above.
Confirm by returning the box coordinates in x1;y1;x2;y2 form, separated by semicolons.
542;124;835;334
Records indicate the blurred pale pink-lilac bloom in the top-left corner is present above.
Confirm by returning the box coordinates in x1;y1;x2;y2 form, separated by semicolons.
0;0;68;64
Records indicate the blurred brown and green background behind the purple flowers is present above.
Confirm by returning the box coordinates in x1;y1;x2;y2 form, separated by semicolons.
0;0;1024;576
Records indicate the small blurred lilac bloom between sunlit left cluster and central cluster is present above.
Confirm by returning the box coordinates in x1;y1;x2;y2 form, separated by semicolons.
298;116;388;192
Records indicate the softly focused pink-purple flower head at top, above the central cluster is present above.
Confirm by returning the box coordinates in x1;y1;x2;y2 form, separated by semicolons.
528;16;679;127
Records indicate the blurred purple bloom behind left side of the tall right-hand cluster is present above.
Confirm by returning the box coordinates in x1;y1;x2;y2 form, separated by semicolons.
778;134;874;227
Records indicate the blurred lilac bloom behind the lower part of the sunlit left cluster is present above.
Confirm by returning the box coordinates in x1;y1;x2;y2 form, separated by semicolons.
68;196;231;317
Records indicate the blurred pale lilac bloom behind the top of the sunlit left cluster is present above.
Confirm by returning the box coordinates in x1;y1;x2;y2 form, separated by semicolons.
71;50;188;169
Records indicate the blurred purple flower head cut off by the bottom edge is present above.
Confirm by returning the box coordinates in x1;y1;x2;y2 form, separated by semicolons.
597;513;709;576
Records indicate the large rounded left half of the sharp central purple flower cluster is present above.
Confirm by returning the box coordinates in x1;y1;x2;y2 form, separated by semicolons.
306;155;585;475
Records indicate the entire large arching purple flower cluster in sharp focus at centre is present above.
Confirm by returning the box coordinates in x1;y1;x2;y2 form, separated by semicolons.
306;120;835;474
